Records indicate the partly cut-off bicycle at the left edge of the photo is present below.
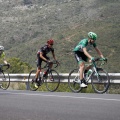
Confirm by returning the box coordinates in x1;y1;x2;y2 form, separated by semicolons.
0;64;10;90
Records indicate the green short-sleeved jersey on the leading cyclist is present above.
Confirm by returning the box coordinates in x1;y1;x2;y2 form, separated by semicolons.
73;38;97;52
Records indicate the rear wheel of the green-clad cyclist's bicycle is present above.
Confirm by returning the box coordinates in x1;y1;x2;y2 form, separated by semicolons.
68;69;82;93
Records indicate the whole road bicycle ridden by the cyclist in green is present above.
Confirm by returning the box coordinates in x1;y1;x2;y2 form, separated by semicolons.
68;58;110;93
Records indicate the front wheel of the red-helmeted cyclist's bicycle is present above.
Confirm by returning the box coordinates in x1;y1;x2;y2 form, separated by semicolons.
45;69;60;92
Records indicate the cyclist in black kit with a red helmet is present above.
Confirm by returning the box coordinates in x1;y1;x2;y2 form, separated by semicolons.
35;39;57;88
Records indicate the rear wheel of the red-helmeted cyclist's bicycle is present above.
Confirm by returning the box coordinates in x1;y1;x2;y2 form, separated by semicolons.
28;70;38;91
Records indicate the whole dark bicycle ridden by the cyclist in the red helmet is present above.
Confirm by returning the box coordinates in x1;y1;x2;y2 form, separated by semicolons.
28;61;60;92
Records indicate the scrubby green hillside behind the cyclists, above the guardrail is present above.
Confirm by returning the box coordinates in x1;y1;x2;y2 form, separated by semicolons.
0;0;120;73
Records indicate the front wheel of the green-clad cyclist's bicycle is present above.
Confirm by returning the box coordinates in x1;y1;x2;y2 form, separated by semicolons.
91;68;110;93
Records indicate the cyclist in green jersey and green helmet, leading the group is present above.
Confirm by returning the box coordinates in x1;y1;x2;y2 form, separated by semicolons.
73;32;106;87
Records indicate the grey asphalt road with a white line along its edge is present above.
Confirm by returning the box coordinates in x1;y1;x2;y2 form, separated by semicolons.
0;90;120;120
